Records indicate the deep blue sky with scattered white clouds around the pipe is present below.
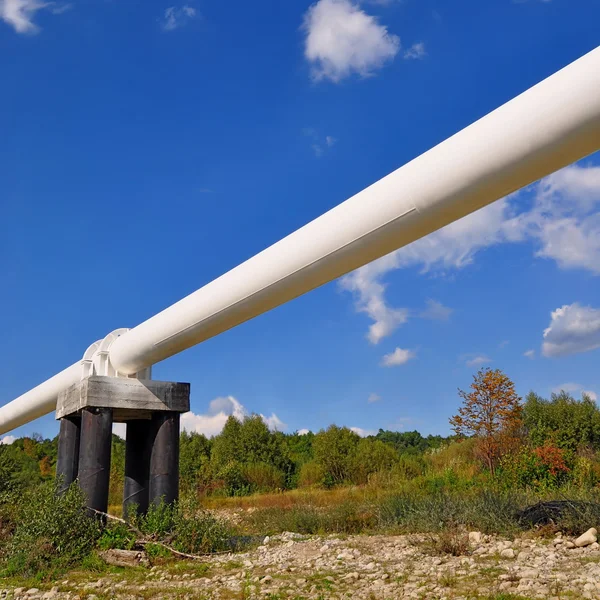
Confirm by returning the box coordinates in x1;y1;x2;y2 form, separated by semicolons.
0;0;600;436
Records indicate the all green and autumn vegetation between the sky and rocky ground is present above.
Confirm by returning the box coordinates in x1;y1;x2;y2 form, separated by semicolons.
0;369;600;578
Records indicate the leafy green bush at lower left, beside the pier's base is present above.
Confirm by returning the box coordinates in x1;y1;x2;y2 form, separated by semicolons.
2;483;101;579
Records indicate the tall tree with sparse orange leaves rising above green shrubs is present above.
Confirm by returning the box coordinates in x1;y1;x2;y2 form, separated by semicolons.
450;368;522;474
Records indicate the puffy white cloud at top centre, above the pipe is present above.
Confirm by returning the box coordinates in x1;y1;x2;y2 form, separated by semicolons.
302;0;400;83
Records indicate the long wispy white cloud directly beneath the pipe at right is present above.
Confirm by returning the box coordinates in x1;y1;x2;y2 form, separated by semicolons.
340;165;600;343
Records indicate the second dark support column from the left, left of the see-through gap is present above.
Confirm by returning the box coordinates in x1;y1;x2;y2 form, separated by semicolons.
79;408;112;512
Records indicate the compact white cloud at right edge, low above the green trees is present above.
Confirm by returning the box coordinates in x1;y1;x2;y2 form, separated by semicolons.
542;302;600;357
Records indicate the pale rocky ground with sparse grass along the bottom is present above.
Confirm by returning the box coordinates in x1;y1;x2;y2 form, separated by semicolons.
0;532;600;600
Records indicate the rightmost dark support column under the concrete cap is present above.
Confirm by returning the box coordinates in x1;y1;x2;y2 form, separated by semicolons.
150;411;179;505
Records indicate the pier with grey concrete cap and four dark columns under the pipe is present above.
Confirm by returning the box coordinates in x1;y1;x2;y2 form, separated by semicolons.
56;375;190;518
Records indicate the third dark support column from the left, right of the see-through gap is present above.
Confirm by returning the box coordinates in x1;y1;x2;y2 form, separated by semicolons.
123;419;152;519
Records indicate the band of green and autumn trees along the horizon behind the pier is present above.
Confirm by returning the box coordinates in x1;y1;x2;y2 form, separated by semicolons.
0;369;600;504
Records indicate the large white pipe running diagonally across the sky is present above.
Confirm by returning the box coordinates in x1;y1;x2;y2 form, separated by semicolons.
0;47;600;433
